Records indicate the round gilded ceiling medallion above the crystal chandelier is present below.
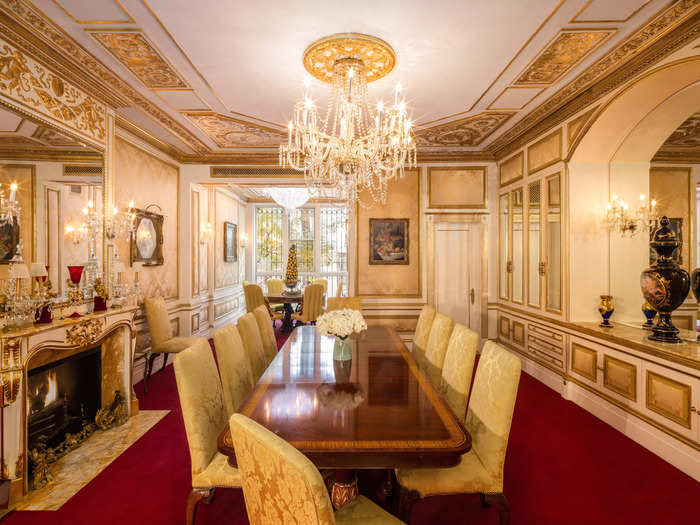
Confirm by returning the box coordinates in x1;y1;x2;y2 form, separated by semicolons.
304;33;396;83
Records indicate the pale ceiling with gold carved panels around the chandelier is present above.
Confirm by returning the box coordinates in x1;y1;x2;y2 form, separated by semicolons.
0;0;692;159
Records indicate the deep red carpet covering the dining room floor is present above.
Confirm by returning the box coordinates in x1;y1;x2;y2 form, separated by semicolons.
2;330;700;525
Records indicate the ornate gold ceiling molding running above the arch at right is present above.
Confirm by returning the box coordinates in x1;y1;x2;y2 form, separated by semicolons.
488;0;700;159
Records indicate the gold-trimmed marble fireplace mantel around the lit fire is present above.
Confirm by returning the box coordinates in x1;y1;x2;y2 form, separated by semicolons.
0;306;138;505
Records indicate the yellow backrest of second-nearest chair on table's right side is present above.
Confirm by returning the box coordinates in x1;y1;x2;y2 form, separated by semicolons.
438;323;479;421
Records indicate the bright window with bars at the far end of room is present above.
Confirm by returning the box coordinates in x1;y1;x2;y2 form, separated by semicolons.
255;204;348;297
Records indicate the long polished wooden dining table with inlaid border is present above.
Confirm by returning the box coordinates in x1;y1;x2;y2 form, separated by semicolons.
218;326;471;508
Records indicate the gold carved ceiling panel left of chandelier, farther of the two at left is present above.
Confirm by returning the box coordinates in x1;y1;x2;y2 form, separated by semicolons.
183;111;284;148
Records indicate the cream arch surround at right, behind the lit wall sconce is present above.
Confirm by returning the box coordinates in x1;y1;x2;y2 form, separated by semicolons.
568;57;700;321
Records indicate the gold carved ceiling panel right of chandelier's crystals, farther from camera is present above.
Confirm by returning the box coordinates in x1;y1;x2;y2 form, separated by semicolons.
416;111;515;147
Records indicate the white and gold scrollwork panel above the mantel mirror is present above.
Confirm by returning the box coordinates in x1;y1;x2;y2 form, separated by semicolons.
0;35;106;142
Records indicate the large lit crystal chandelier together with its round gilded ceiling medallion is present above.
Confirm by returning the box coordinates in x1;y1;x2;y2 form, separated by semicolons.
279;33;416;206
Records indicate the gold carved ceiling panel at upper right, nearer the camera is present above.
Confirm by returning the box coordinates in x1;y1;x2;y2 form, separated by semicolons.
515;30;615;85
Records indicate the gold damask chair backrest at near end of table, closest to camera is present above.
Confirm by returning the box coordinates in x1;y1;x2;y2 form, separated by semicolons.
229;414;335;525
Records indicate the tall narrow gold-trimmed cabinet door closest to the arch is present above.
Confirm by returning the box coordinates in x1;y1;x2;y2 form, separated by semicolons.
545;173;563;313
